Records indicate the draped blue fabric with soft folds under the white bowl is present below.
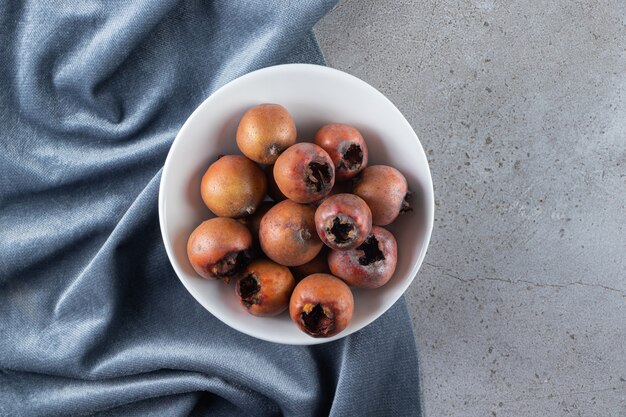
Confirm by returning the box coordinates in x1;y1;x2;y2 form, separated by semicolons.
0;0;420;416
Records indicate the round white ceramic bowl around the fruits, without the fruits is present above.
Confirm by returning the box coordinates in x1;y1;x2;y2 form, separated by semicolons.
159;64;434;345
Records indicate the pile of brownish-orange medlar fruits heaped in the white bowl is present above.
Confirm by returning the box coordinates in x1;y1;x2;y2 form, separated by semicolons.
187;104;411;337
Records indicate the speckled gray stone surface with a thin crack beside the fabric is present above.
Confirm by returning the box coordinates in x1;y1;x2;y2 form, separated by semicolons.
316;0;626;417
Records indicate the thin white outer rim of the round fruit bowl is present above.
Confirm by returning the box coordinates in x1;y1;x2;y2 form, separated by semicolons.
158;63;435;346
